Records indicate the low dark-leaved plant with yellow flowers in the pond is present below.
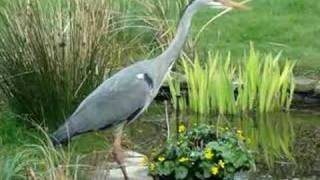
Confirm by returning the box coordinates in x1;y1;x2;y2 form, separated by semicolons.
148;125;254;179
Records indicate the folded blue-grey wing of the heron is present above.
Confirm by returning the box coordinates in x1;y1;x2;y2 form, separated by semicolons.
67;75;151;134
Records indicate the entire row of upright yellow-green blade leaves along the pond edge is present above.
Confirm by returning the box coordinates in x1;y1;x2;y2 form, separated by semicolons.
170;47;295;114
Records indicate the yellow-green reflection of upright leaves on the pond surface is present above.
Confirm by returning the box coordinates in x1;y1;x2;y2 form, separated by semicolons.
182;113;295;167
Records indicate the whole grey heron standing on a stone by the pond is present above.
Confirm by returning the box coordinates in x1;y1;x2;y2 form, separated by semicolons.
52;0;248;179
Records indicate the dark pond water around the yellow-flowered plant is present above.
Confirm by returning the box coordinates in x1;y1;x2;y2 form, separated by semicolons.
126;106;320;179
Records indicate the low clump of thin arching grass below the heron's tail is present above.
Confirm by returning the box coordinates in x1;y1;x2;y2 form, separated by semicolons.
0;126;89;180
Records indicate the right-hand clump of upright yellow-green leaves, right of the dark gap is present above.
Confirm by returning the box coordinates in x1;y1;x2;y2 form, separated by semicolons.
237;47;295;113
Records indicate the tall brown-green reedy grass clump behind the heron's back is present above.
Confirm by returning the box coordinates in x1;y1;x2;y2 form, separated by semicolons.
0;0;142;126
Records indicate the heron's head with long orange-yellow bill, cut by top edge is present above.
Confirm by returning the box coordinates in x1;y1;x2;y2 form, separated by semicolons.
194;0;248;9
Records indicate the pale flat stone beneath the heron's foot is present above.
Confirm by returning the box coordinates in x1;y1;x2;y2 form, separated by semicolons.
107;152;153;180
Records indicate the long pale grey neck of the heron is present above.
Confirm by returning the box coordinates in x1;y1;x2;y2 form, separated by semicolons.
156;5;198;69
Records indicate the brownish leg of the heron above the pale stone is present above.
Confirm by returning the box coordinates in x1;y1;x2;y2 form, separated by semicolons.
112;123;129;180
